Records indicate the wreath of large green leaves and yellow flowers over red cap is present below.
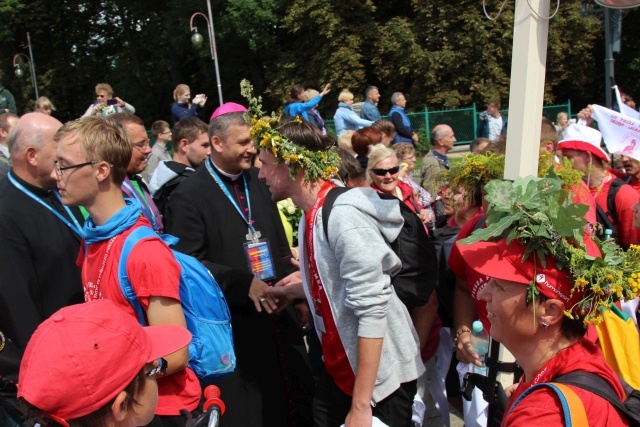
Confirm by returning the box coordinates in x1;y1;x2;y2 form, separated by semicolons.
461;176;640;324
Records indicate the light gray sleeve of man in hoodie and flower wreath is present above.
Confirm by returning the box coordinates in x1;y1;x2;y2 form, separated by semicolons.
329;206;397;338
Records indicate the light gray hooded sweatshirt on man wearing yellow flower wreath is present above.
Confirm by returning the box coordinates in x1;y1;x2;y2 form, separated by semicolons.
299;188;424;402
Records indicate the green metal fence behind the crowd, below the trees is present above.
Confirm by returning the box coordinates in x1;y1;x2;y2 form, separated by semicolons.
325;100;571;151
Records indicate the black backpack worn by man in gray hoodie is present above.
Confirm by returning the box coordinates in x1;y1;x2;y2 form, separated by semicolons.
322;187;438;308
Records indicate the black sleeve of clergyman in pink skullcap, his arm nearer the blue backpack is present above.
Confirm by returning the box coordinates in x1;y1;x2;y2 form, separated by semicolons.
165;186;253;306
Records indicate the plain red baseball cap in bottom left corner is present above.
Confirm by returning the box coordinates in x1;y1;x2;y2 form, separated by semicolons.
18;300;191;425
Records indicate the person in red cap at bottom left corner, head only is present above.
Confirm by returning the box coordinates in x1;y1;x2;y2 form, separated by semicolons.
18;300;191;427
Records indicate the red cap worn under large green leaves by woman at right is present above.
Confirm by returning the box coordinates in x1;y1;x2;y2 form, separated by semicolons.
458;239;582;309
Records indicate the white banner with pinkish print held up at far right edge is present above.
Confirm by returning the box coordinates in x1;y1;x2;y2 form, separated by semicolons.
591;104;640;160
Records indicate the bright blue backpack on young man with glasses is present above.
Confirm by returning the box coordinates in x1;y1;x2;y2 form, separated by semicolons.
118;227;236;382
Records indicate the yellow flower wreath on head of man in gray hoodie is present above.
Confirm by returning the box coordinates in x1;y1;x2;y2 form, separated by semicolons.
240;79;340;182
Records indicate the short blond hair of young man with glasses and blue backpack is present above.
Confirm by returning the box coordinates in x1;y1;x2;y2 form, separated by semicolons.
53;116;133;185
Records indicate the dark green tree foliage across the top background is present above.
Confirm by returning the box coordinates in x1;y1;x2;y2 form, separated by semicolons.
0;0;640;123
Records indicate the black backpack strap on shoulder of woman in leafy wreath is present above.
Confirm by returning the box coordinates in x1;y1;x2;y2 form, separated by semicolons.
552;371;640;427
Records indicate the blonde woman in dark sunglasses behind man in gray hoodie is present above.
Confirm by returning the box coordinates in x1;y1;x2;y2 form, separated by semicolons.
367;144;430;222
